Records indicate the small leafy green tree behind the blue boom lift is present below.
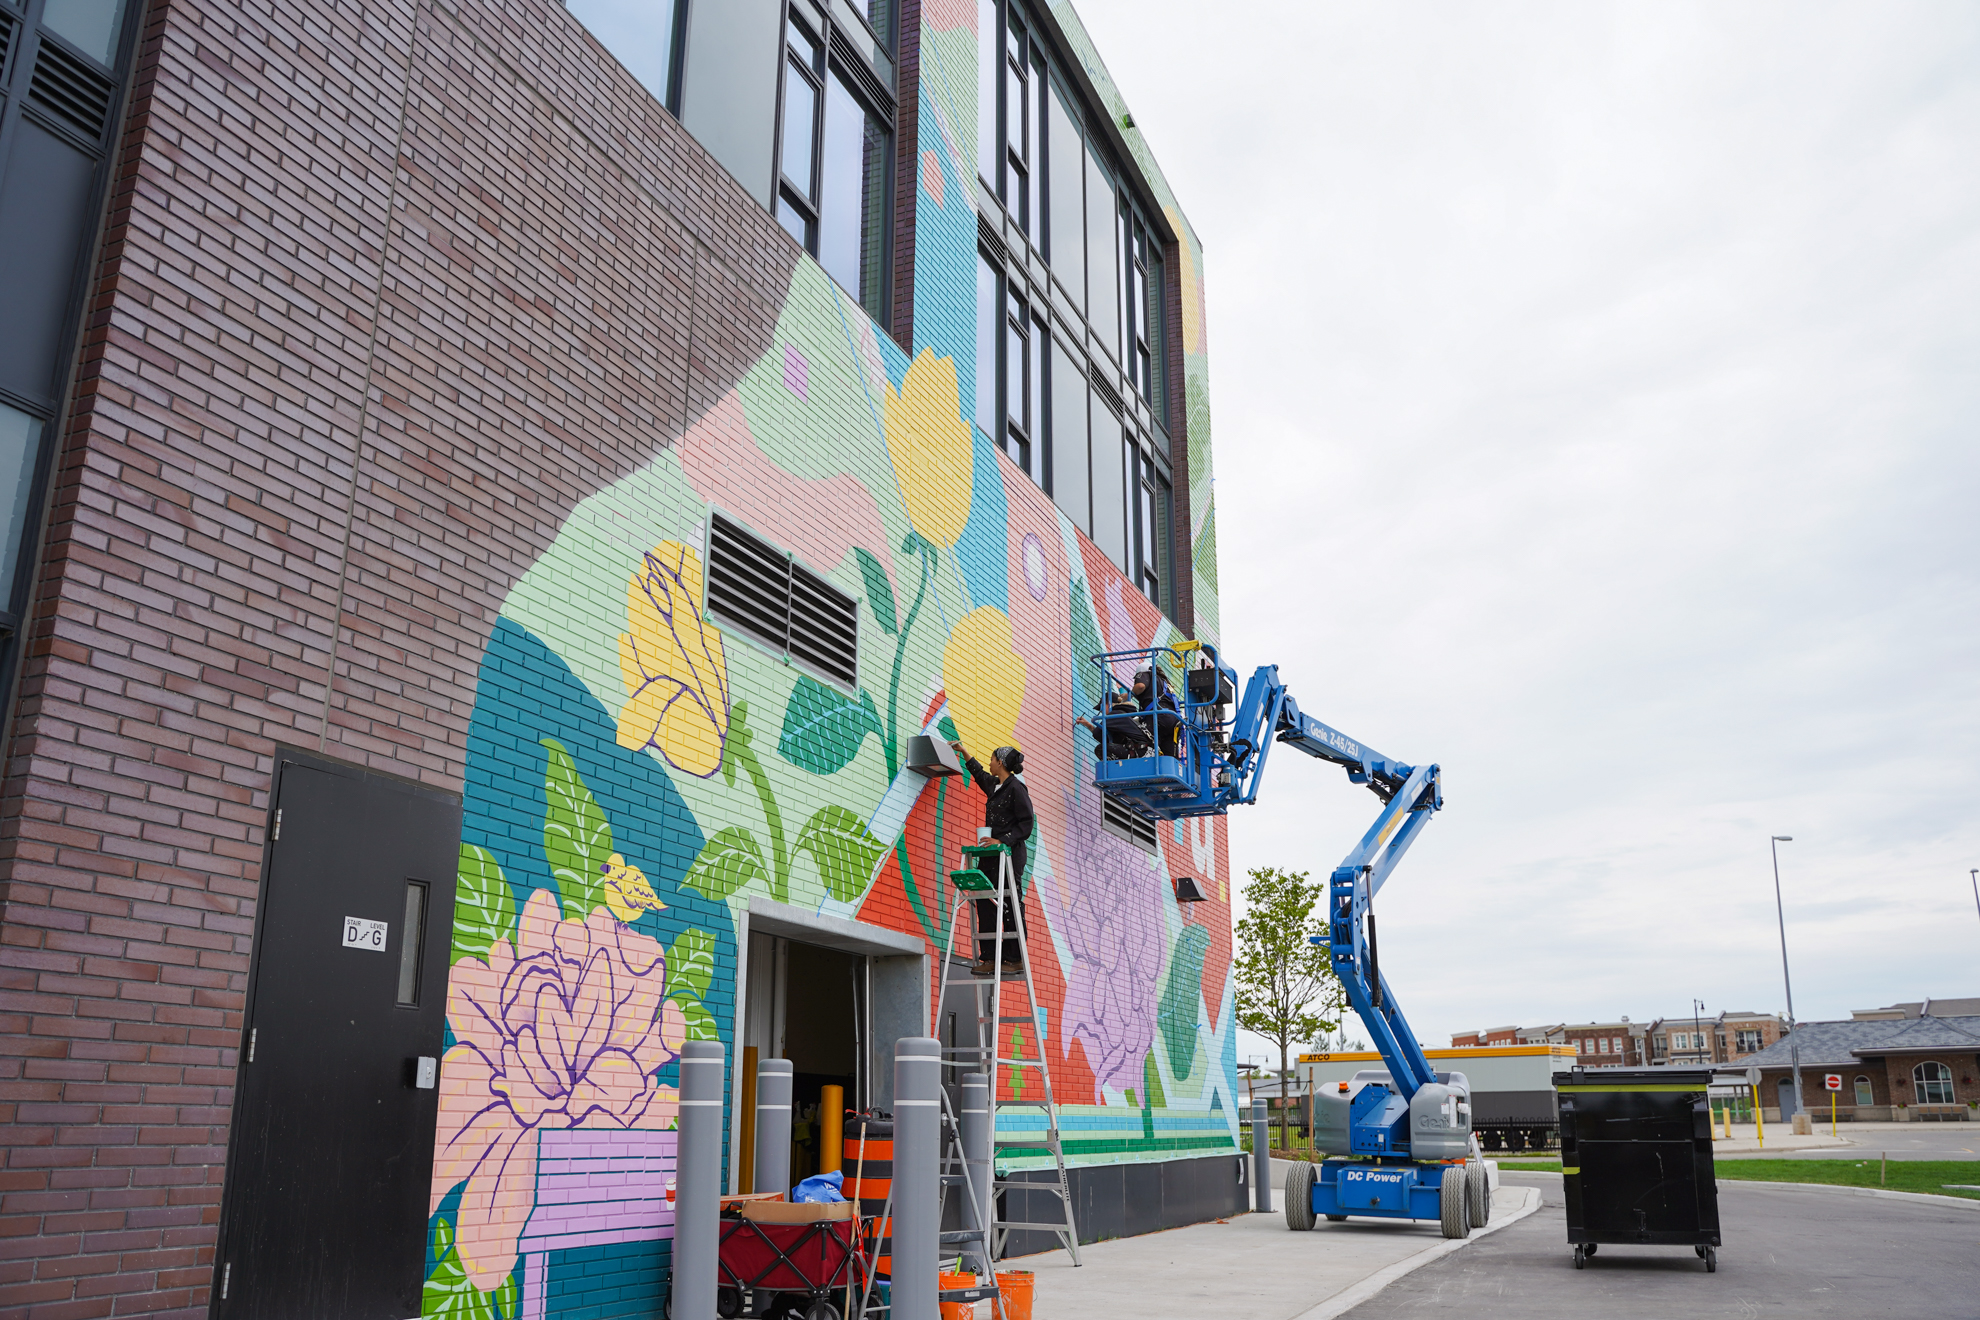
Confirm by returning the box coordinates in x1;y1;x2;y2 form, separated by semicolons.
1238;867;1346;1146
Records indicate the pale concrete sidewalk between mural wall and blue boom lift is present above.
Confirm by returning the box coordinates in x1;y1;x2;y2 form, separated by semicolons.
1010;1185;1540;1320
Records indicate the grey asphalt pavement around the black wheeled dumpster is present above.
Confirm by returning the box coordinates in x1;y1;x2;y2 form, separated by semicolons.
1346;1174;1980;1320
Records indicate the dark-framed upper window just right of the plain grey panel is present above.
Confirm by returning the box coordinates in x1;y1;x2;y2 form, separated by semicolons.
776;18;893;321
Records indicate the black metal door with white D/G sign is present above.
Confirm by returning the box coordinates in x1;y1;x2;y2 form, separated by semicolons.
214;752;461;1320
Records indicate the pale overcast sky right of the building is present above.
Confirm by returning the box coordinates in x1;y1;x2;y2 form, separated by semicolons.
1079;0;1980;1055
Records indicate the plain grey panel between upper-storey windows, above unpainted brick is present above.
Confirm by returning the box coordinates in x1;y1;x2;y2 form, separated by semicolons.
681;0;784;206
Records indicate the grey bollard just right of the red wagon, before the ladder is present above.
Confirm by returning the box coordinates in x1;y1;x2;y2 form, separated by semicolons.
891;1035;942;1320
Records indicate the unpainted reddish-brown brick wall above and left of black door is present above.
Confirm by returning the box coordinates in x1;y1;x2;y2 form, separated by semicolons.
0;0;796;1316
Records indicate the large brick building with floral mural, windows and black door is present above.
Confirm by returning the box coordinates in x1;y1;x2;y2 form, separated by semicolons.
0;0;1241;1316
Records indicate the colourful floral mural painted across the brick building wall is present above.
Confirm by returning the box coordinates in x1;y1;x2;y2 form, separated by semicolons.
424;0;1238;1320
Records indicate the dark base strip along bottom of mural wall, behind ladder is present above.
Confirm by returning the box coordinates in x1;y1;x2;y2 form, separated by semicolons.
998;1152;1251;1257
